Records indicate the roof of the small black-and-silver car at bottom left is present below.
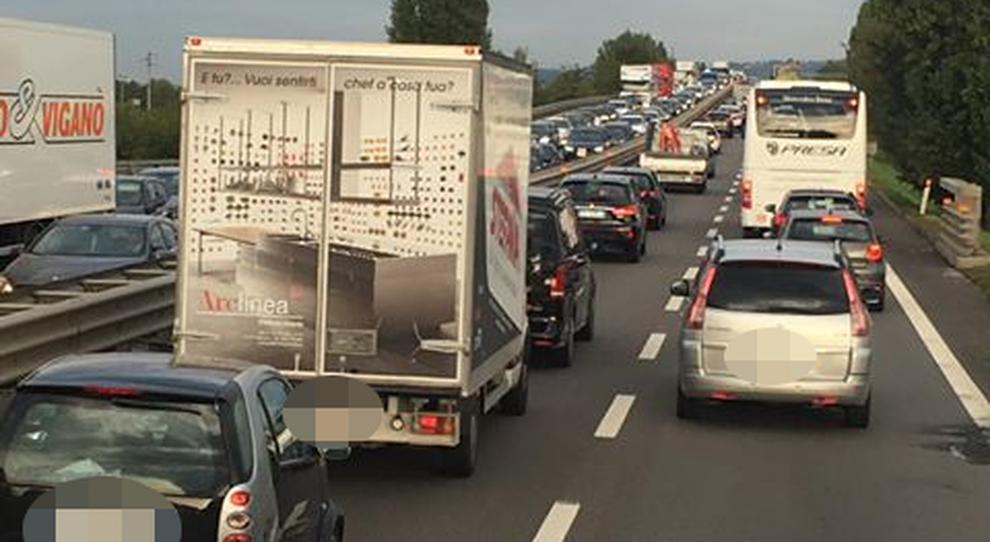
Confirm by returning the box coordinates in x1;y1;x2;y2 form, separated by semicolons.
17;352;253;399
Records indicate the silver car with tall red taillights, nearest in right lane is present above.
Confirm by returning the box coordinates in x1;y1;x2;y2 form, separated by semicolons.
671;238;872;427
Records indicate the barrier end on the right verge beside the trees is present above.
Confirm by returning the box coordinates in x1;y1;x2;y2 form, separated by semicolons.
935;178;990;269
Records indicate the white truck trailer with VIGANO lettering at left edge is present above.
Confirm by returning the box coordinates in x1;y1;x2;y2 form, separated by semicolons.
0;19;116;269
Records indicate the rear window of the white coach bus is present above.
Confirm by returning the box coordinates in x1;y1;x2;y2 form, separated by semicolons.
756;89;859;139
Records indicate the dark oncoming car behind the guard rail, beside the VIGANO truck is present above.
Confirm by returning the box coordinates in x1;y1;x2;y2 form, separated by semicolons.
3;214;179;289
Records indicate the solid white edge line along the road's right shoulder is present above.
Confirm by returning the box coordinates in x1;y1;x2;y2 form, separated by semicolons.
887;265;990;429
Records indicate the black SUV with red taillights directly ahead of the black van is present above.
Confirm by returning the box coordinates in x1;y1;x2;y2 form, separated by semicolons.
560;173;648;263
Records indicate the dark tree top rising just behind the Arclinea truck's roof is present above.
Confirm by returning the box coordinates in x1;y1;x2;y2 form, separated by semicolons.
385;0;492;50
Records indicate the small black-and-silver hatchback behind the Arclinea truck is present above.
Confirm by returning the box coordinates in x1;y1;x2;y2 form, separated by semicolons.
0;353;344;542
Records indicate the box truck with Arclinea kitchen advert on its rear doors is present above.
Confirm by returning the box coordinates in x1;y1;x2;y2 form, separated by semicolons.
175;37;533;476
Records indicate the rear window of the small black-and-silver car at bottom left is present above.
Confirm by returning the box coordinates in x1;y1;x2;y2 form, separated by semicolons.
0;393;231;497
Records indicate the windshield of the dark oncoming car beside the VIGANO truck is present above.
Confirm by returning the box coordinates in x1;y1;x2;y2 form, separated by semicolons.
30;224;146;258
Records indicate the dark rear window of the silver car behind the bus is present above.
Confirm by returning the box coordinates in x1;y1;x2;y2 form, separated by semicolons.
708;262;849;315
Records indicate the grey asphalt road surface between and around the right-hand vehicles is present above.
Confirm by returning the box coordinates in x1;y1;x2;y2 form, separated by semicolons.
333;139;990;542
